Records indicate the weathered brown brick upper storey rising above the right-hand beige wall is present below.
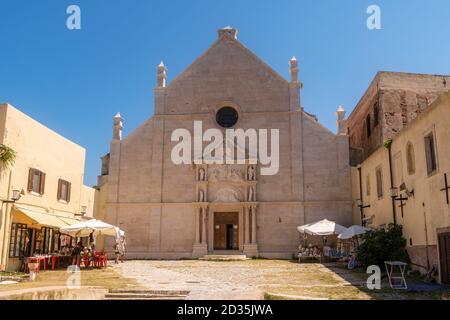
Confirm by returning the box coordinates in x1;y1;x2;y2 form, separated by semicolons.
347;72;450;163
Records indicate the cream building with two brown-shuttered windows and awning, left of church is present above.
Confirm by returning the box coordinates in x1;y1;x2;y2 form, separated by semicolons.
0;104;96;271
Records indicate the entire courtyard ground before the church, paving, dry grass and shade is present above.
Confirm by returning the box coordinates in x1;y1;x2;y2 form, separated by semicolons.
0;259;450;300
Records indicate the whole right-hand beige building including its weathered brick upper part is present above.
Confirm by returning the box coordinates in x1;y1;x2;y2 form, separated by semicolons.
346;73;450;283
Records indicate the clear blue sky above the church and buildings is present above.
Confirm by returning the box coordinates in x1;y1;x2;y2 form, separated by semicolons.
0;0;450;185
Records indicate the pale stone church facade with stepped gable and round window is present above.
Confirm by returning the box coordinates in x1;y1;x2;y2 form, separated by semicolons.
99;28;352;259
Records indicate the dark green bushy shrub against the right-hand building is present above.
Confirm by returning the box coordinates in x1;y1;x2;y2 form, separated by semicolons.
357;224;410;269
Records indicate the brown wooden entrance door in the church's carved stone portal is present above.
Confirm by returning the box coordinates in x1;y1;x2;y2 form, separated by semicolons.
214;212;239;250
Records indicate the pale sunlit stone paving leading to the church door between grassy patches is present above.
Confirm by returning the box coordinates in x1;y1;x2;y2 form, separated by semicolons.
114;260;356;300
